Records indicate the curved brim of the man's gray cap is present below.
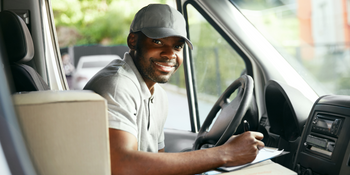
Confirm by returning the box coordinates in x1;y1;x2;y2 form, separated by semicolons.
141;28;193;50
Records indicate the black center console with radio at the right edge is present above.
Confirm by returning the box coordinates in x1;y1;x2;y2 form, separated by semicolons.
294;96;350;175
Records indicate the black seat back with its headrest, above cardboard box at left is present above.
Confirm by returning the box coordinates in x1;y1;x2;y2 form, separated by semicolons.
0;10;50;92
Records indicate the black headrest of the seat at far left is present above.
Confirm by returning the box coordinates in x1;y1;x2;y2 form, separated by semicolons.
0;10;34;63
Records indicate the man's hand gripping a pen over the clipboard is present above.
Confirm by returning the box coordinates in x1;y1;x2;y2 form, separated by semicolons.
220;131;265;166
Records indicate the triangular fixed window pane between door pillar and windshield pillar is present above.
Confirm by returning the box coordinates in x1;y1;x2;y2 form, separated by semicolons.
187;4;245;124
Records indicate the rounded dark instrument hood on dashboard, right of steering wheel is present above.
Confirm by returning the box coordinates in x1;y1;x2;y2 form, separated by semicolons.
265;80;313;141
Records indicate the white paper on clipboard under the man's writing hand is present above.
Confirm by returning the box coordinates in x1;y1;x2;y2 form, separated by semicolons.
219;147;283;171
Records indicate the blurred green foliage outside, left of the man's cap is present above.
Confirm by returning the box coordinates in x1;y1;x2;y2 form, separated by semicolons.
51;0;172;47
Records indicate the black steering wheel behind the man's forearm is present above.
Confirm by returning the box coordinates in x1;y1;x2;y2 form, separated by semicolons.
192;75;254;150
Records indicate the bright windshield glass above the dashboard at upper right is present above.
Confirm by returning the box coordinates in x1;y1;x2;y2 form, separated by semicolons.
232;0;350;96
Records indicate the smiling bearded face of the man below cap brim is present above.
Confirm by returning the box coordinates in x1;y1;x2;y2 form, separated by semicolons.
134;33;185;87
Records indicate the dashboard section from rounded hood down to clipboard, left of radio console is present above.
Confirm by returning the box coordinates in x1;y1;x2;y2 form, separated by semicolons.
264;80;314;169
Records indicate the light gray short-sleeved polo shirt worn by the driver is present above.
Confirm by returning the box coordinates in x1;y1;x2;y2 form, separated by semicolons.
84;53;168;152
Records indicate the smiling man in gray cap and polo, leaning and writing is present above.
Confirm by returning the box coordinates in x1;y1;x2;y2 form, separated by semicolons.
85;4;264;175
